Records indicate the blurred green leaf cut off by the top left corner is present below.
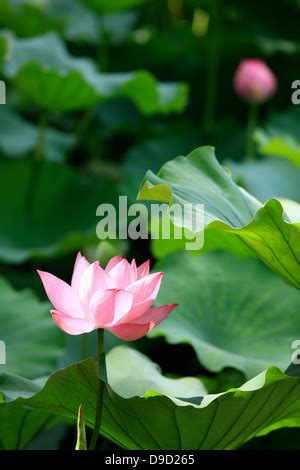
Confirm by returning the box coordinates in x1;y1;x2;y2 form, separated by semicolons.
0;0;137;44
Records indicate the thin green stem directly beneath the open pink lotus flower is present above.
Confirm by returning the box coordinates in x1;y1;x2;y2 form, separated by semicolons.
89;328;105;450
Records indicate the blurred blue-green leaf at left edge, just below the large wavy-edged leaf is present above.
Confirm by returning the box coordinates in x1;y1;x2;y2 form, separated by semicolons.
0;106;73;162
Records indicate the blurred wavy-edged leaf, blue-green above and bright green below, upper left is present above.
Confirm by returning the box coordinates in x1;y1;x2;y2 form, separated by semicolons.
4;34;187;114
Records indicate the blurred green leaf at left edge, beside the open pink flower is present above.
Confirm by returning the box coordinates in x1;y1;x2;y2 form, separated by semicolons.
0;278;64;380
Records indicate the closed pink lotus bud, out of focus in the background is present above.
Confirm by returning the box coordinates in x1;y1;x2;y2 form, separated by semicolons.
233;59;277;104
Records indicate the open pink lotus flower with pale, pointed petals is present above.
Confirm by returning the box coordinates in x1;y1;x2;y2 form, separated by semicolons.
38;253;176;341
